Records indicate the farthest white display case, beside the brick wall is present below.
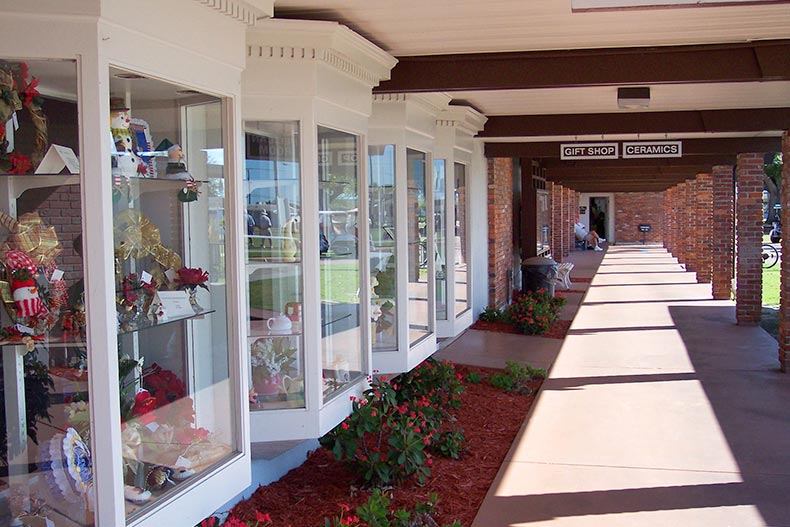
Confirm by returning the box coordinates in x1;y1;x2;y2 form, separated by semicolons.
434;106;487;338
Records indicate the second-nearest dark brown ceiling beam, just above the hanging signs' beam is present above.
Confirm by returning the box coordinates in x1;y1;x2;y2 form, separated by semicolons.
478;108;790;138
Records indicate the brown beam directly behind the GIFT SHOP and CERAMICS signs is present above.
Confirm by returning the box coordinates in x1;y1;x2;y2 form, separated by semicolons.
485;137;782;159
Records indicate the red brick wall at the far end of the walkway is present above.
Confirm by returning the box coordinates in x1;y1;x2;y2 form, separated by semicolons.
614;192;664;243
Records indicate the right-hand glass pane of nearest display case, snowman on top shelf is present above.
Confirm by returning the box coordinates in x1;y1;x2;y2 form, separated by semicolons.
108;68;237;517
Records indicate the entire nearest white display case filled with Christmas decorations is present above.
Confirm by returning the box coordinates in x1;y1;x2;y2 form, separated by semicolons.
0;0;271;527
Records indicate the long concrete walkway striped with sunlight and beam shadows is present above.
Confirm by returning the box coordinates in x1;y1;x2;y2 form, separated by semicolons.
448;246;790;527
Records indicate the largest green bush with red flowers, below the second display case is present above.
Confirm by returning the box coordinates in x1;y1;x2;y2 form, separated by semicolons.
320;360;465;486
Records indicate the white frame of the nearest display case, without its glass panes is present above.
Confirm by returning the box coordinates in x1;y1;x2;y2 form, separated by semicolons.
0;0;263;527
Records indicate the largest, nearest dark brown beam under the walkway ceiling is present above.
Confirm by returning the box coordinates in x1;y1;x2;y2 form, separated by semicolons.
374;39;790;93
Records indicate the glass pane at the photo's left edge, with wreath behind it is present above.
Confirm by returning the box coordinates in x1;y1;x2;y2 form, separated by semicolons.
0;60;95;526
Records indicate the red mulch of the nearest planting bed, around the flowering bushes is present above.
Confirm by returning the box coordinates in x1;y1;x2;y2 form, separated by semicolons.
226;365;541;527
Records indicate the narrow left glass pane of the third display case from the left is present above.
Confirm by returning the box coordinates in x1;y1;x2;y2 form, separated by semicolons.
368;145;398;352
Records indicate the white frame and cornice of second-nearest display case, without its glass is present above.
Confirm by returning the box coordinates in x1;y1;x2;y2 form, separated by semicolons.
242;20;395;443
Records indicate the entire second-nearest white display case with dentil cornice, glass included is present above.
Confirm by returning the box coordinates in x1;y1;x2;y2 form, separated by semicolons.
242;20;395;442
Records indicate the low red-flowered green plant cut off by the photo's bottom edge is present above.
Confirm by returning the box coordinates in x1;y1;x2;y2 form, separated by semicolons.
324;489;462;527
